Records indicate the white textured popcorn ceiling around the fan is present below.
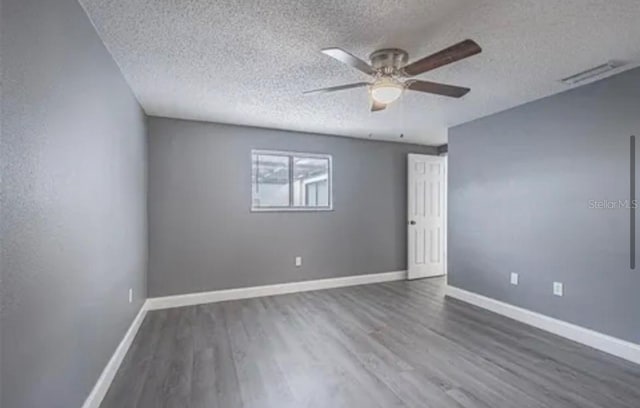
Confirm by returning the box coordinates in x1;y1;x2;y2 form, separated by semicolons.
81;0;640;144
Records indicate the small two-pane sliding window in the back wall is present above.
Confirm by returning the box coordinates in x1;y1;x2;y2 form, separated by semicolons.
251;150;333;211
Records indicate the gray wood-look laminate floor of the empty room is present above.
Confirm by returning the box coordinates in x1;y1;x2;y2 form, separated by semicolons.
101;278;640;408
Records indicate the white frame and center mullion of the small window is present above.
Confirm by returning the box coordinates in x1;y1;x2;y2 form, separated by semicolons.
249;149;333;212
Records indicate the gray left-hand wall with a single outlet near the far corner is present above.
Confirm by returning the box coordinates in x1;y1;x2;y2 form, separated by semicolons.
0;0;147;408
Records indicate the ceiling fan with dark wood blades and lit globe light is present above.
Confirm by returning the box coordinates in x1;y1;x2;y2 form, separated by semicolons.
304;40;482;112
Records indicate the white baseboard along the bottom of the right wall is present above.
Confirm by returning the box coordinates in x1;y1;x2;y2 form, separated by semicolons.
446;286;640;364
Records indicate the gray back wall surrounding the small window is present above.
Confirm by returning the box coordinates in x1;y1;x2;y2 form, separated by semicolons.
148;118;434;296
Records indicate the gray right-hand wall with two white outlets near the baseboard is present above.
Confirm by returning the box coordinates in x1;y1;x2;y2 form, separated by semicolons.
449;69;640;343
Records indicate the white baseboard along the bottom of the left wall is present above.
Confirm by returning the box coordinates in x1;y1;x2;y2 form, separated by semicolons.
82;302;147;408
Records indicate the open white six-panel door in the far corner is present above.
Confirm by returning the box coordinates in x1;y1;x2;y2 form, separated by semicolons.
408;154;447;279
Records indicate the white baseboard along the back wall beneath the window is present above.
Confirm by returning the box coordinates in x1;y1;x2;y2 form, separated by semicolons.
147;271;407;310
